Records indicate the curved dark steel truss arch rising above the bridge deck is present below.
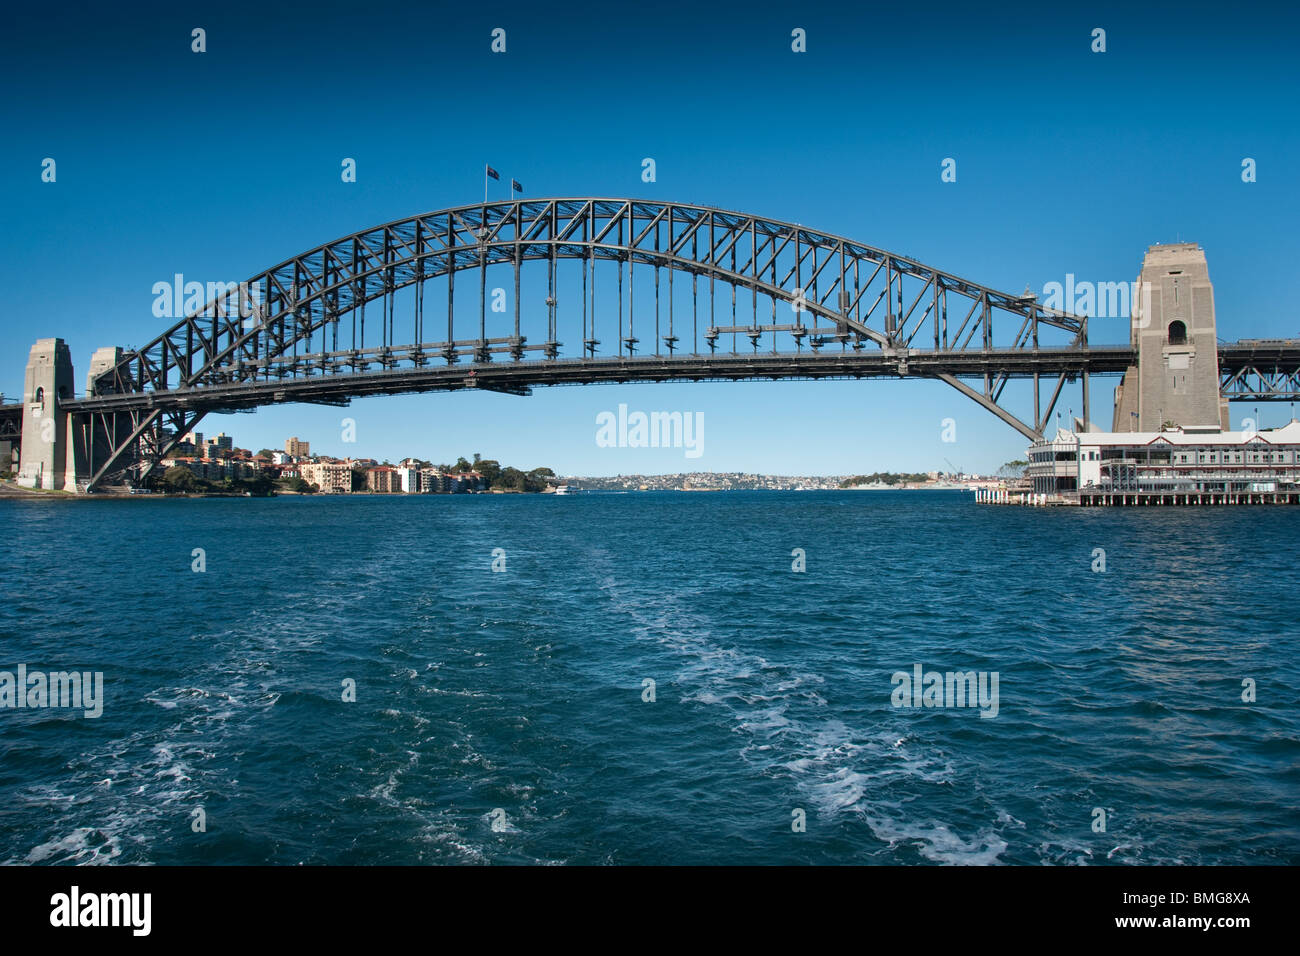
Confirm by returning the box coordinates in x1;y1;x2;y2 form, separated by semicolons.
86;199;1084;393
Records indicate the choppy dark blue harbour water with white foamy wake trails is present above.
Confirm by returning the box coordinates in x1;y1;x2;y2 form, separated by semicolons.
0;492;1300;864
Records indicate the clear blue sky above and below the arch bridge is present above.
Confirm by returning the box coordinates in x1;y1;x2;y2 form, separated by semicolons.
0;3;1300;475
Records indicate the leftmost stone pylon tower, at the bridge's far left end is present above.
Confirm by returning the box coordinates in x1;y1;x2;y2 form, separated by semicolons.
18;338;75;490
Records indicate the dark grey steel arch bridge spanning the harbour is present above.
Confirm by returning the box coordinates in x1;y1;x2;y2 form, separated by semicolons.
0;198;1300;490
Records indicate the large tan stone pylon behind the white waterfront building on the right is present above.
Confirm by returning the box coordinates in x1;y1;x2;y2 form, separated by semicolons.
1112;242;1229;432
